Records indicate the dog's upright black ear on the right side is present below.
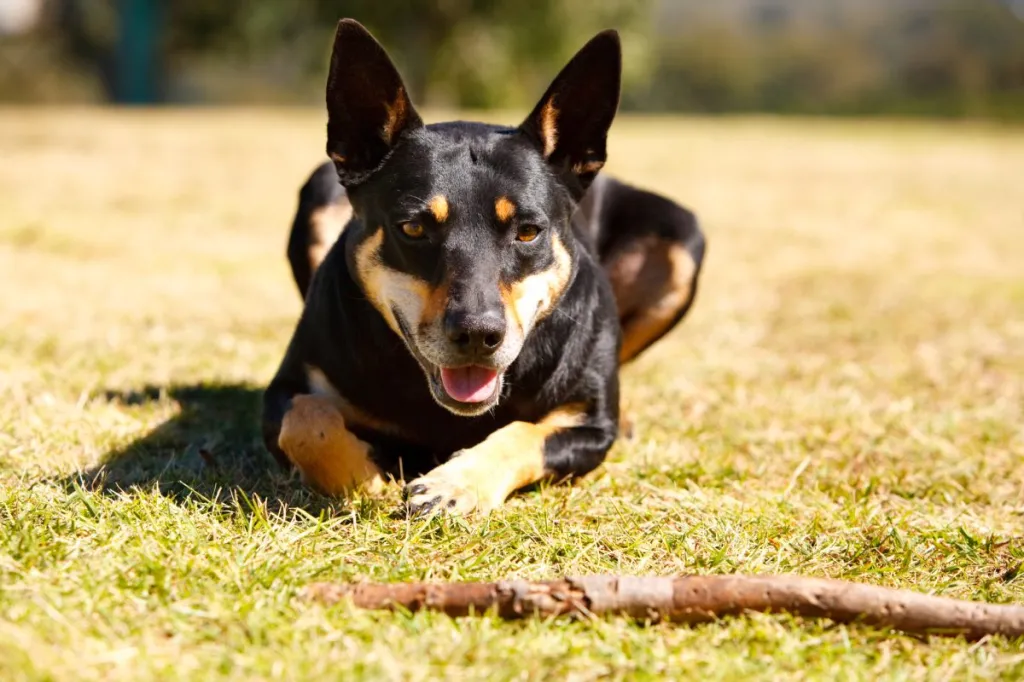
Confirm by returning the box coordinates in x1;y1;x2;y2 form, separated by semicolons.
520;31;623;195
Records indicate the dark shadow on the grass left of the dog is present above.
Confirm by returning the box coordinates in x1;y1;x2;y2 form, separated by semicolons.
60;384;348;515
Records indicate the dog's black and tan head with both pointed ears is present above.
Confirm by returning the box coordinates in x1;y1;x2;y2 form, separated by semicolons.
327;19;622;416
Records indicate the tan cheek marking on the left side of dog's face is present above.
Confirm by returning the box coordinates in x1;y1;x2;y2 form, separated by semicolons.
355;227;430;341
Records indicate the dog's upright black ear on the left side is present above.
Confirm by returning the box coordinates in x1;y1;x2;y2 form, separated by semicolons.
327;19;423;186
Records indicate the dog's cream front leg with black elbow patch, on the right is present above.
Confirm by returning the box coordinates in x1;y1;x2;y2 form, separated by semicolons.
406;406;615;514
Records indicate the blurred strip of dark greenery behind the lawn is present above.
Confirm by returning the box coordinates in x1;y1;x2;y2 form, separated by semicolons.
0;0;1024;120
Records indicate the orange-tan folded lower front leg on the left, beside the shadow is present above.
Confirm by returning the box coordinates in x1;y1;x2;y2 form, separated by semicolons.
278;395;384;495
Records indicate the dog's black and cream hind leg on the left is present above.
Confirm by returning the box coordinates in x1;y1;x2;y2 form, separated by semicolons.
288;162;352;299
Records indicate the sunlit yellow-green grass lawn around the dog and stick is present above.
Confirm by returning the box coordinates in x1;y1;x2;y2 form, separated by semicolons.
0;110;1024;682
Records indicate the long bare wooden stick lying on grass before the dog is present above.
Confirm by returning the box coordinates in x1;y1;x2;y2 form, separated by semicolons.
303;576;1024;640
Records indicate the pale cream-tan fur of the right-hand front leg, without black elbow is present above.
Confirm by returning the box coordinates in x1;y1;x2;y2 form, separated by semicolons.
409;403;587;514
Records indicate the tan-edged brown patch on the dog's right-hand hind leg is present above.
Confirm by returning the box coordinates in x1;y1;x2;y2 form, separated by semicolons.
608;239;696;363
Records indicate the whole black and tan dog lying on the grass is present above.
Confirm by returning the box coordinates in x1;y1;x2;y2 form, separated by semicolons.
263;19;705;513
